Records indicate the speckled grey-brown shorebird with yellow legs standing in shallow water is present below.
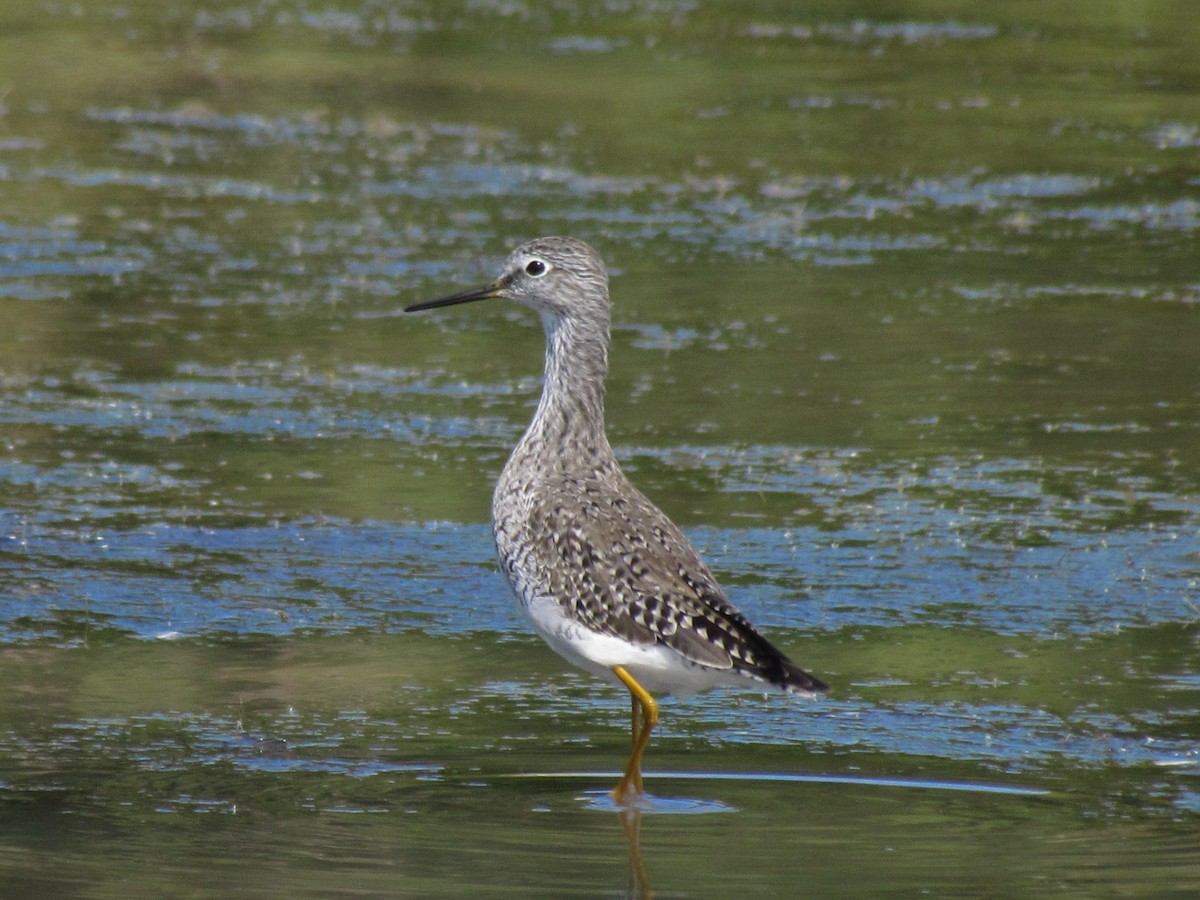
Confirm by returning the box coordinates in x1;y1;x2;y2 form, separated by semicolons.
407;238;826;805
